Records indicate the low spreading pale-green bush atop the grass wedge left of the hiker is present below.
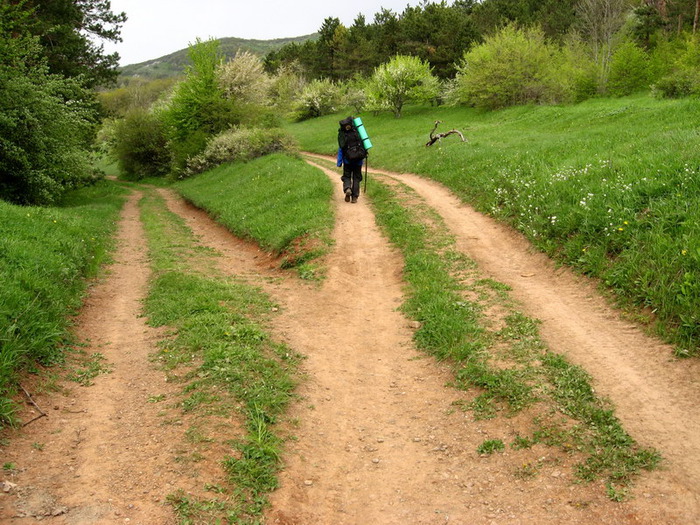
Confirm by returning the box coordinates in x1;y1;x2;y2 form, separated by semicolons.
183;127;296;177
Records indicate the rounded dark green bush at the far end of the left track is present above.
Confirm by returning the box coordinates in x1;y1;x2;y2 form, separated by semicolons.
113;109;170;180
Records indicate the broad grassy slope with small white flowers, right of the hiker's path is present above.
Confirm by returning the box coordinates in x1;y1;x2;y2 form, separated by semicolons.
288;96;700;355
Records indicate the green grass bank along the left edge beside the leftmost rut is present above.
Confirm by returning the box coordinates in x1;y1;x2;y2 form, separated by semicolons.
0;182;125;425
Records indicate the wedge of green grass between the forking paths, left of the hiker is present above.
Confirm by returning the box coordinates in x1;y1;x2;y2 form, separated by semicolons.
174;154;334;275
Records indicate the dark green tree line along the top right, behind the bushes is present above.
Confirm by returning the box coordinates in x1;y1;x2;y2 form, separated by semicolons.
265;0;700;81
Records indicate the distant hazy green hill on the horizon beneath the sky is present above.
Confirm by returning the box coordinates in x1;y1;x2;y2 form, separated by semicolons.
119;33;318;81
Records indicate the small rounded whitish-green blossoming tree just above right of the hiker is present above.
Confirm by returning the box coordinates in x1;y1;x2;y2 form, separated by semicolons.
367;55;439;118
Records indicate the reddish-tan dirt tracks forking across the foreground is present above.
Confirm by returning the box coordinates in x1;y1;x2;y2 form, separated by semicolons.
0;161;700;525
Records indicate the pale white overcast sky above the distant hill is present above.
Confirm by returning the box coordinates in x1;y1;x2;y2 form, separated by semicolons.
105;0;420;66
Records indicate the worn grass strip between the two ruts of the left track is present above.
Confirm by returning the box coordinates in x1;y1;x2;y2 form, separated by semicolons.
142;188;300;523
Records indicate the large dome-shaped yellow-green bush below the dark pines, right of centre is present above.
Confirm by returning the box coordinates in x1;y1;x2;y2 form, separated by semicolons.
456;25;573;109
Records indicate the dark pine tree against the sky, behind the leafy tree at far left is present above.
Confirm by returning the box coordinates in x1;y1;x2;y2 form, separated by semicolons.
19;0;126;88
